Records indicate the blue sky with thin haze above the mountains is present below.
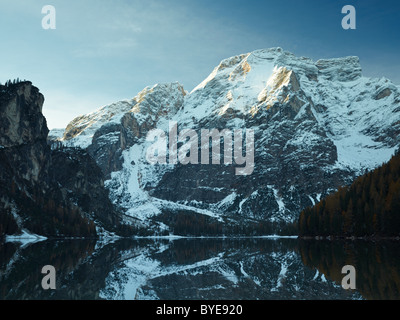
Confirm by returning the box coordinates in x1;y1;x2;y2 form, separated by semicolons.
0;0;400;128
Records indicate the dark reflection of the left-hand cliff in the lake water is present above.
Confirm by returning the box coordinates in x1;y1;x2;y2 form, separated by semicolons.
0;239;168;300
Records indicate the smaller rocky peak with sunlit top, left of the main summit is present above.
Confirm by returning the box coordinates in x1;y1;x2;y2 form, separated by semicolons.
64;83;186;178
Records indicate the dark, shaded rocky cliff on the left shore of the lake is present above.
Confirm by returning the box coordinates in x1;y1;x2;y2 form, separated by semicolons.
0;81;122;237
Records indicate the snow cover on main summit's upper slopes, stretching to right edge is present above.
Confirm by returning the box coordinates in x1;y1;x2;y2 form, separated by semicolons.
177;48;400;169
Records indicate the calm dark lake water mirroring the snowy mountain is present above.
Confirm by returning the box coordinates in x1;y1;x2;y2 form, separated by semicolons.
0;238;400;300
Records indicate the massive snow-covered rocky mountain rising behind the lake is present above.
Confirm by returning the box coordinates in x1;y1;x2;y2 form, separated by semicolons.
50;48;400;229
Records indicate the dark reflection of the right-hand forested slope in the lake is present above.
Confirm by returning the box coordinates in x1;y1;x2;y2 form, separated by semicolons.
299;240;400;300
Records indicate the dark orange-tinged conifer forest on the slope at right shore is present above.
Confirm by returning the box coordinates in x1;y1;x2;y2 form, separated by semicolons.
299;150;400;237
